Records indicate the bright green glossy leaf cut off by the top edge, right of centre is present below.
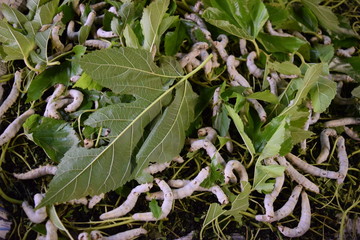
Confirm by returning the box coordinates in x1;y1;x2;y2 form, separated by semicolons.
202;0;269;40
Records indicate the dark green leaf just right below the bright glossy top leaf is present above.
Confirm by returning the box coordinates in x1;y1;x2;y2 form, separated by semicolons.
257;32;307;53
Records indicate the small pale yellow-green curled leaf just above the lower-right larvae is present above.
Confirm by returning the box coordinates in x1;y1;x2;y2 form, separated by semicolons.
253;160;285;193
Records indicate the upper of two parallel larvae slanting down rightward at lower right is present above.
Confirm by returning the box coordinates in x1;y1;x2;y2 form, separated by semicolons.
286;153;340;179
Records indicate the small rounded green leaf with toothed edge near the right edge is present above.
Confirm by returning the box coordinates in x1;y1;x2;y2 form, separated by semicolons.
309;77;337;113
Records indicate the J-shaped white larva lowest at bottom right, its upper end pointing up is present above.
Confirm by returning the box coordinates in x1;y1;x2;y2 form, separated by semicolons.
278;191;311;237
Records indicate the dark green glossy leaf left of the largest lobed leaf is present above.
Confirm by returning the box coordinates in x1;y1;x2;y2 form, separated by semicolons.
24;115;79;163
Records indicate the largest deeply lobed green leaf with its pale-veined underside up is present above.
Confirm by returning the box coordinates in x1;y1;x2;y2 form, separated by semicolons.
38;49;196;205
